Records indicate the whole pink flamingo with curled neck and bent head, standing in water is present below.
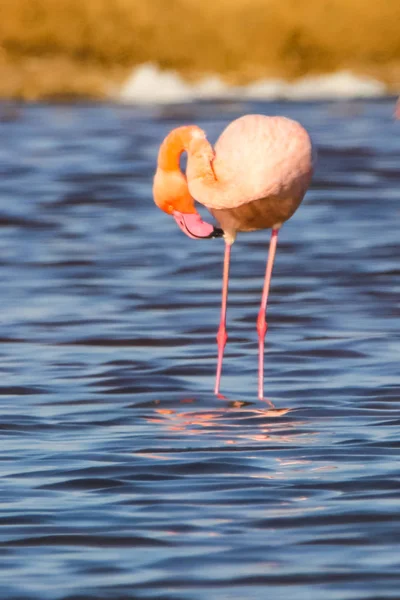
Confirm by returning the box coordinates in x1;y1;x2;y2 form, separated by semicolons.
153;115;312;398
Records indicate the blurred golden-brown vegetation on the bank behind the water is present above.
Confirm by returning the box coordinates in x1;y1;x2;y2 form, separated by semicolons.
0;0;400;99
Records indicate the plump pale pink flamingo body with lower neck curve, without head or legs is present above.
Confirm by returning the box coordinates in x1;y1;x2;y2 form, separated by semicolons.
187;115;313;240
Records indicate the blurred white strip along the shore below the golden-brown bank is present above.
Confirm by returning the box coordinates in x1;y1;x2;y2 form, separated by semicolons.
117;63;387;104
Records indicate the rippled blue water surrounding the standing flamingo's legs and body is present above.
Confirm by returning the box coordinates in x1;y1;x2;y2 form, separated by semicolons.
0;99;400;600
